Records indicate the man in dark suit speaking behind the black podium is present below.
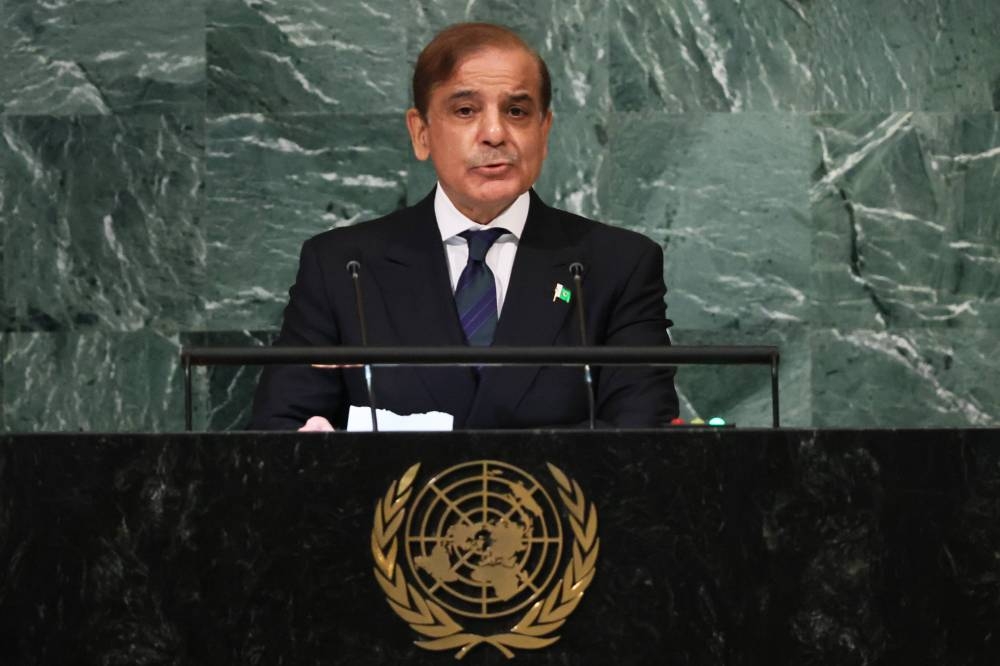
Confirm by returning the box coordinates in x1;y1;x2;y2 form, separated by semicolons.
251;23;677;430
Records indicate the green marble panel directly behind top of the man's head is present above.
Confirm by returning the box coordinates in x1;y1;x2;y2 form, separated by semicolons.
407;0;610;113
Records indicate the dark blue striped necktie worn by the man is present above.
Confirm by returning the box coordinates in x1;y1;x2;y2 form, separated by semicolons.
455;228;509;347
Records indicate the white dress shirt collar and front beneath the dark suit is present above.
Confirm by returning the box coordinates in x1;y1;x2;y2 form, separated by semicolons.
434;183;531;316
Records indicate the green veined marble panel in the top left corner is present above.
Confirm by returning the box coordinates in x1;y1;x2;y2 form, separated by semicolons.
0;0;205;115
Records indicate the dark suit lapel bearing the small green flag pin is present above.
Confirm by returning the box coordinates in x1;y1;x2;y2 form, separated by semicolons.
469;191;586;423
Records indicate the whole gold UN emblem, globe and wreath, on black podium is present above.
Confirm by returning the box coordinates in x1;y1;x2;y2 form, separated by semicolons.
371;460;600;659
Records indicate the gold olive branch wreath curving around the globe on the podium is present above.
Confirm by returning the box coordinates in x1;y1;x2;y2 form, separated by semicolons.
371;463;601;659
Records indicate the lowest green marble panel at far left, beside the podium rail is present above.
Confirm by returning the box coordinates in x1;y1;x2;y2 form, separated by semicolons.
3;331;184;432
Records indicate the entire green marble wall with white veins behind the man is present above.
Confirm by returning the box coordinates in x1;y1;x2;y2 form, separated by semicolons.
0;0;1000;431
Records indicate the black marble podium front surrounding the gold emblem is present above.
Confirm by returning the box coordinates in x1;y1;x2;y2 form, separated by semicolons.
0;430;1000;666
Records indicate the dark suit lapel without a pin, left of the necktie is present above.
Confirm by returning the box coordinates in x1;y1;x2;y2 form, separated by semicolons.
372;191;475;423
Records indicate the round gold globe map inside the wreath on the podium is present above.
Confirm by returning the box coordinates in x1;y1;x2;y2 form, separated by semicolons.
404;460;562;618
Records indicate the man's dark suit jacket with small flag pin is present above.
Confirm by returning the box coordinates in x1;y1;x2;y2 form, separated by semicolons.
250;192;677;429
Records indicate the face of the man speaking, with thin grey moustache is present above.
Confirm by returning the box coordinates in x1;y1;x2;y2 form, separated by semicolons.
406;47;552;224
